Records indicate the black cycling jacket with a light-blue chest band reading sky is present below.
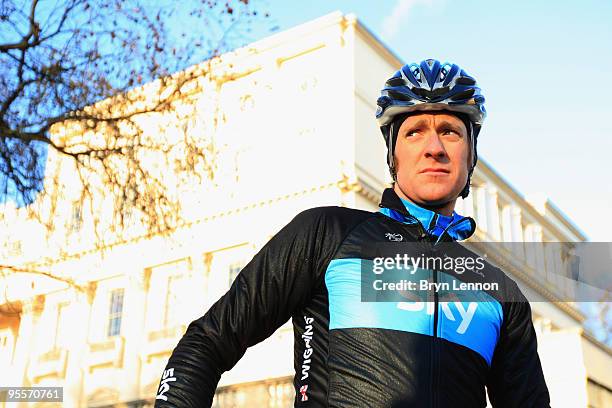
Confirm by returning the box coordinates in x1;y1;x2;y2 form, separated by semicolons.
155;189;549;408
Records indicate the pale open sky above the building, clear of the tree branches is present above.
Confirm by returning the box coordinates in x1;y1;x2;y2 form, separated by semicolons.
244;0;612;242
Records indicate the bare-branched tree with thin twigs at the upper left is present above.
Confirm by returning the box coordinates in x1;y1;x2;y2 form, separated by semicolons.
0;0;267;243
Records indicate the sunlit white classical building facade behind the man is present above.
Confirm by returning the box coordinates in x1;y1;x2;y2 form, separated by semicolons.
0;13;612;408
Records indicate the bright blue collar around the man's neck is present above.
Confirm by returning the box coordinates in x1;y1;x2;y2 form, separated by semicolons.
379;188;476;241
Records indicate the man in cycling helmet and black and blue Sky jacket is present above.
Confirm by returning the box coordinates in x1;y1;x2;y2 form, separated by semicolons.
155;60;549;408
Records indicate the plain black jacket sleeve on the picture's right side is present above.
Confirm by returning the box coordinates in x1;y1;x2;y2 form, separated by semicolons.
487;282;550;408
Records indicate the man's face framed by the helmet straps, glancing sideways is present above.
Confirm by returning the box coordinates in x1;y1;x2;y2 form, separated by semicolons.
395;112;471;206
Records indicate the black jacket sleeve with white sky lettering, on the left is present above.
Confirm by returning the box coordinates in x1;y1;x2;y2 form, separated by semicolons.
155;208;329;408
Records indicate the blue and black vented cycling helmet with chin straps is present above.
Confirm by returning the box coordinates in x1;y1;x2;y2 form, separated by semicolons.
376;59;487;197
